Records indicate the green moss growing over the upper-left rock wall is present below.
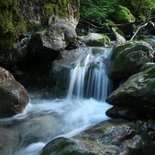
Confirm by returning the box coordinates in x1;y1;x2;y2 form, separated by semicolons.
0;0;70;49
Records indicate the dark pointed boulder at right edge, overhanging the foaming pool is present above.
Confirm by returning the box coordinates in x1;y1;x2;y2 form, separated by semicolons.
107;66;155;115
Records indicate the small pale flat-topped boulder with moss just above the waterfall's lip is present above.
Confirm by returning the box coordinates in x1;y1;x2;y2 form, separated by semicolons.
80;33;110;46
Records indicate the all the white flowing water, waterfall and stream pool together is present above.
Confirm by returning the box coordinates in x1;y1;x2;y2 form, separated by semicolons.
0;48;111;155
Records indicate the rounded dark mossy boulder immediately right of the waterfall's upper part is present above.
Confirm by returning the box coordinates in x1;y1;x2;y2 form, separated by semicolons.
108;41;153;80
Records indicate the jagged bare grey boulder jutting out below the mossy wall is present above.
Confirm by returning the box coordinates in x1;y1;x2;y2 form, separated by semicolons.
31;16;76;58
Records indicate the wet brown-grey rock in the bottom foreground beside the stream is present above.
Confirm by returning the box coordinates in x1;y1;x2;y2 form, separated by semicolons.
42;119;154;155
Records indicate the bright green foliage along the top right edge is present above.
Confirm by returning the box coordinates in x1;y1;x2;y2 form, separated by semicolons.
81;0;155;22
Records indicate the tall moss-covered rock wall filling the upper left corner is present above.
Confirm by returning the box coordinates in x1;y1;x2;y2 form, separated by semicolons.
0;0;80;64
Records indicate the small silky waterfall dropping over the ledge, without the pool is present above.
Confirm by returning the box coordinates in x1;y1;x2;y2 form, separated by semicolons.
67;47;111;101
